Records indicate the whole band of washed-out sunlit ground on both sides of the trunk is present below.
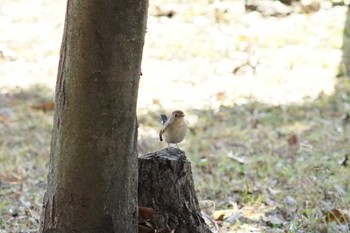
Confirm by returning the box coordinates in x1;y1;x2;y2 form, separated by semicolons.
0;0;346;108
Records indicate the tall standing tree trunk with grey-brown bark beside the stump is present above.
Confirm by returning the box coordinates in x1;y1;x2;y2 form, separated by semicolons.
40;0;148;233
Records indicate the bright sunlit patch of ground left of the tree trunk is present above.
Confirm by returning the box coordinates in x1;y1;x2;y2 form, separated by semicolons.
0;0;66;89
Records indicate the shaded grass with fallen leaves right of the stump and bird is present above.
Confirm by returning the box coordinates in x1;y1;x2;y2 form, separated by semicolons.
140;78;350;232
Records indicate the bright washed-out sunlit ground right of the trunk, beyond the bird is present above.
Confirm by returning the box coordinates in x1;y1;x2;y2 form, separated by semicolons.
139;1;346;109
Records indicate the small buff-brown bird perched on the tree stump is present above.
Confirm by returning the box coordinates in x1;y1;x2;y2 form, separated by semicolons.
159;110;188;147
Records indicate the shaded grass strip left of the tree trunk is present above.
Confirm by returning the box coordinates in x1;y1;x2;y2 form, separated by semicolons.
0;87;53;232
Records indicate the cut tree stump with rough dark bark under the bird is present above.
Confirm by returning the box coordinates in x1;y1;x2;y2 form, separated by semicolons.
138;148;211;233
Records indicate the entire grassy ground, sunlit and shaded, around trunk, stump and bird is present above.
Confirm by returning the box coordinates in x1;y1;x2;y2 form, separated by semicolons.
0;0;350;233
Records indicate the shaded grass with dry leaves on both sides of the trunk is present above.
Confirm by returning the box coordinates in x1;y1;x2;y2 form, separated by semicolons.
0;81;350;232
